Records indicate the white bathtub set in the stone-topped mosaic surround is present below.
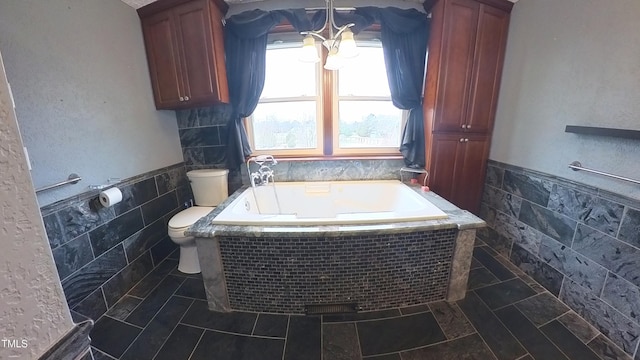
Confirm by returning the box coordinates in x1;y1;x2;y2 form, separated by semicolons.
212;180;447;226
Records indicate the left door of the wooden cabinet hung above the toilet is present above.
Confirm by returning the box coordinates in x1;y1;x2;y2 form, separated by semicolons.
142;11;182;109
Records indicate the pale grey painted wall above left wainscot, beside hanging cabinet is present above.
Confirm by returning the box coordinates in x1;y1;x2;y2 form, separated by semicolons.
0;0;183;206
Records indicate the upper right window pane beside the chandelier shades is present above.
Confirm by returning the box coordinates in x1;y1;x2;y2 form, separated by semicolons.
338;47;391;97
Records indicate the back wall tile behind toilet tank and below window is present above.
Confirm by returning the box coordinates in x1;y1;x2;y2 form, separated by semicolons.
176;105;410;194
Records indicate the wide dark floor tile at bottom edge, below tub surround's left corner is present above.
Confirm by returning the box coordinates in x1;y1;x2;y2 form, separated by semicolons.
190;330;282;360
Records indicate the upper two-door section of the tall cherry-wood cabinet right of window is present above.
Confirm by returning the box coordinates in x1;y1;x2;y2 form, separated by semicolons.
425;0;511;133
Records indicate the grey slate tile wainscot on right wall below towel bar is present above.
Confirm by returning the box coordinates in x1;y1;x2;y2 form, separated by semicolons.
478;160;640;359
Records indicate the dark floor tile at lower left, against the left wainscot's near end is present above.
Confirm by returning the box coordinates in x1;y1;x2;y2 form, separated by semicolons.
90;316;142;358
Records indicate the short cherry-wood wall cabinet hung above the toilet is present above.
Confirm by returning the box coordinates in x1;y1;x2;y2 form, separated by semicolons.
138;0;229;109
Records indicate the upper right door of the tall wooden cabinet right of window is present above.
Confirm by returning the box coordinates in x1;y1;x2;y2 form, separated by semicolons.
467;4;509;133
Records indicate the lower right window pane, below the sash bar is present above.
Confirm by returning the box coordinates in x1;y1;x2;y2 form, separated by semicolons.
338;100;402;148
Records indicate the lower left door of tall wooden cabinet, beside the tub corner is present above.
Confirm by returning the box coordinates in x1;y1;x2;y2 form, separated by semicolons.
429;134;464;201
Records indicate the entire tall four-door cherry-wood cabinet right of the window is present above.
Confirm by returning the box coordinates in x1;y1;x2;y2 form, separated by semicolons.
424;0;513;213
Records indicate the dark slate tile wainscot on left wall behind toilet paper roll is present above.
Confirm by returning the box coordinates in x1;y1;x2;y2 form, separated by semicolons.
40;163;192;320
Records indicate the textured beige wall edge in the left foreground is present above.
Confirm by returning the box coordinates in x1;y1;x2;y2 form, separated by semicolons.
0;50;73;360
